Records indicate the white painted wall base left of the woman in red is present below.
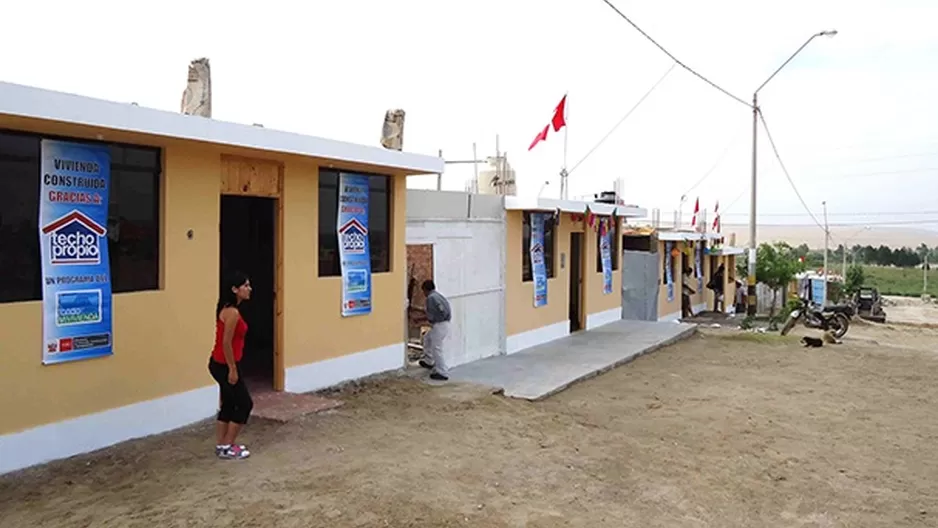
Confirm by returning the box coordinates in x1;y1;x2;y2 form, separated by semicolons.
0;385;218;474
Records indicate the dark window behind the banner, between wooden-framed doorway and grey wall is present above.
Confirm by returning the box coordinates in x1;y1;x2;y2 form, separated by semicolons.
319;169;393;277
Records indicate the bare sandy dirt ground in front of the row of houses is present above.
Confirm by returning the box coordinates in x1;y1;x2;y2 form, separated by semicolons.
0;325;938;528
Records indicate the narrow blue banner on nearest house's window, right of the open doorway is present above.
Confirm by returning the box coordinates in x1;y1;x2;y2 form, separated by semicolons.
336;173;371;317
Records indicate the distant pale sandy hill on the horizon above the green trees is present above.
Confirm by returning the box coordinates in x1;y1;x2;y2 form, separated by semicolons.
723;224;938;249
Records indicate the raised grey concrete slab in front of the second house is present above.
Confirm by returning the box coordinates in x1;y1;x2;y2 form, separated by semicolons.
450;321;697;401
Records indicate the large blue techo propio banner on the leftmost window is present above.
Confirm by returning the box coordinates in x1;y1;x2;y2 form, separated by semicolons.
39;139;113;365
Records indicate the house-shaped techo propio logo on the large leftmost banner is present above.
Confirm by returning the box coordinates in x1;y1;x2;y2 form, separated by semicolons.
42;210;107;265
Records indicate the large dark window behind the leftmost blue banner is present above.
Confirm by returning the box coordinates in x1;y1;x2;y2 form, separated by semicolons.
0;130;162;303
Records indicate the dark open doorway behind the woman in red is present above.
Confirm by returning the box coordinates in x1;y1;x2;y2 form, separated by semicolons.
219;196;277;390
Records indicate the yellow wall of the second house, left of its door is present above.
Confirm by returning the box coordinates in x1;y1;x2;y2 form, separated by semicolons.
505;211;580;336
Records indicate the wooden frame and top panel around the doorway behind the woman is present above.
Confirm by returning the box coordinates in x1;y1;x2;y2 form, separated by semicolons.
218;154;286;391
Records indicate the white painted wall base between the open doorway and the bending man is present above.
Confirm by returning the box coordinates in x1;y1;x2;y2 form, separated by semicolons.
284;343;406;392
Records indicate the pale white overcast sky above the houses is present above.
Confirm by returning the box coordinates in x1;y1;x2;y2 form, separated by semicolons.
0;0;938;229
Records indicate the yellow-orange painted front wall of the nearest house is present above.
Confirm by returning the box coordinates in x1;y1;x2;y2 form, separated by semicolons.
0;115;408;434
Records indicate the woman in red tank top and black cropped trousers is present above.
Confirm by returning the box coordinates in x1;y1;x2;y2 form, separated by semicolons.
208;272;254;459
